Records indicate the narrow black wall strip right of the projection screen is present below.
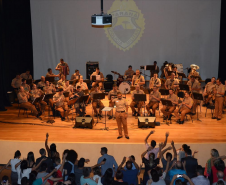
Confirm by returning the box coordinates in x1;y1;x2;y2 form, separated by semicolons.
219;0;226;80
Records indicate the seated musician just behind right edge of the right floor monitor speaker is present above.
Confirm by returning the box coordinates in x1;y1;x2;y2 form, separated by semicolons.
146;86;161;117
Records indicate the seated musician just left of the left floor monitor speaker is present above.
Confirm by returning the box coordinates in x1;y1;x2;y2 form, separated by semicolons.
53;88;69;121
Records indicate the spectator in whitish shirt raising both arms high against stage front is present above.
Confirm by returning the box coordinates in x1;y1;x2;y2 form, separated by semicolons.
144;130;169;159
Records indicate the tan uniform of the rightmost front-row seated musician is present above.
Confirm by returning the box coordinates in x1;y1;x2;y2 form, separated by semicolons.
174;96;193;121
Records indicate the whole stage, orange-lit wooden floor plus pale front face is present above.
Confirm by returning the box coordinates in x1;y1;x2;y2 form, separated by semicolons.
0;95;226;166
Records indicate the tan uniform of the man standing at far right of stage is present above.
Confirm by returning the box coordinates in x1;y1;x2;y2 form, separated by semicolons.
215;84;225;119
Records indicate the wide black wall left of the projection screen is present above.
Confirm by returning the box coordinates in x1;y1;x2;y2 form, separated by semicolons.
0;0;33;109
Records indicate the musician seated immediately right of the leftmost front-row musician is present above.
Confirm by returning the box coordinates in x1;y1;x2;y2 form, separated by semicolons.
31;84;47;112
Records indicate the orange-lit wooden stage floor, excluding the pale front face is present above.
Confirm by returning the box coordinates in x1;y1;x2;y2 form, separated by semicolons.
0;95;226;144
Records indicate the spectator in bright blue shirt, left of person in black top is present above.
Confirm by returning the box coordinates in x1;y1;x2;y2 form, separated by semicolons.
168;161;186;185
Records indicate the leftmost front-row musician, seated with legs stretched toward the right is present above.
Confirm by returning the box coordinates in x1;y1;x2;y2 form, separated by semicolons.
17;86;42;119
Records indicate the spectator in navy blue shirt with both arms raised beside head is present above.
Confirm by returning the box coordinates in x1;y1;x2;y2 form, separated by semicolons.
118;157;139;185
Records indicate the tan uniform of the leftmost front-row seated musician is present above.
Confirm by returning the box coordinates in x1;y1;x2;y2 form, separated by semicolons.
17;92;38;116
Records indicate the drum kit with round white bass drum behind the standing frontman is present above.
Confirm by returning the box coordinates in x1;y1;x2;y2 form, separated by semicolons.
111;71;132;94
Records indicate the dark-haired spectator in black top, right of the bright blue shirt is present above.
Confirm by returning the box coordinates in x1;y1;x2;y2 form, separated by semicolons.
181;149;198;178
